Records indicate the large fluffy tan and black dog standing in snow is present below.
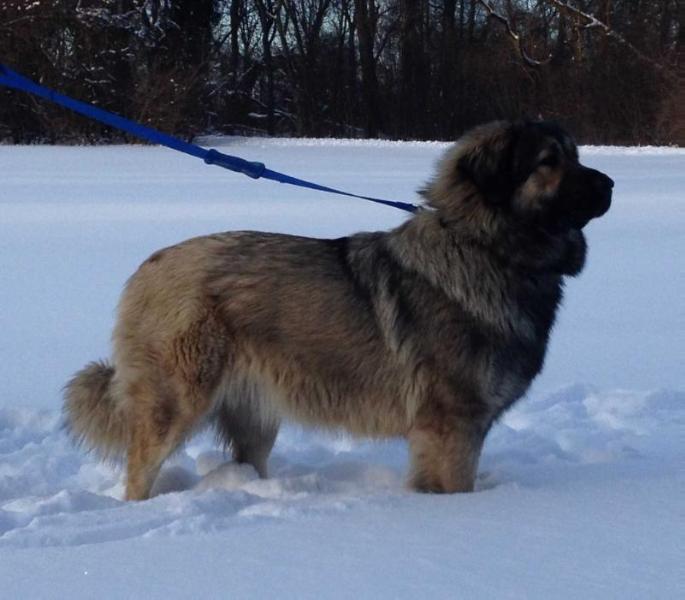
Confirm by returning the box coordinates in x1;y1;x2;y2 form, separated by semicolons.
65;122;613;499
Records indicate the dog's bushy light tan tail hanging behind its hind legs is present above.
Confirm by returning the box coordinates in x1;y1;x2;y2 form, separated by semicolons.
64;362;128;459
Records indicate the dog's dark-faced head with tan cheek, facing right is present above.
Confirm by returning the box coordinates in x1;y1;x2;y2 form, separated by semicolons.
424;121;614;231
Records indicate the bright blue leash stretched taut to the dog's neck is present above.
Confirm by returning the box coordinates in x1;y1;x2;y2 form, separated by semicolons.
0;63;419;213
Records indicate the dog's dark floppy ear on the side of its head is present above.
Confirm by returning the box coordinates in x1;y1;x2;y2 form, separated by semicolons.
457;126;514;205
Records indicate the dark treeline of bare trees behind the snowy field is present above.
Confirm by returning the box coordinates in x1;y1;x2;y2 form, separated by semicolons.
0;0;685;144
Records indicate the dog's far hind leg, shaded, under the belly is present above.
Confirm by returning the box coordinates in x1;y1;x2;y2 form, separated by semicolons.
216;390;280;479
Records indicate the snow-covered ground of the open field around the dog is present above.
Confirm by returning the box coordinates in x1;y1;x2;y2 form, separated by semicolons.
0;139;685;599
